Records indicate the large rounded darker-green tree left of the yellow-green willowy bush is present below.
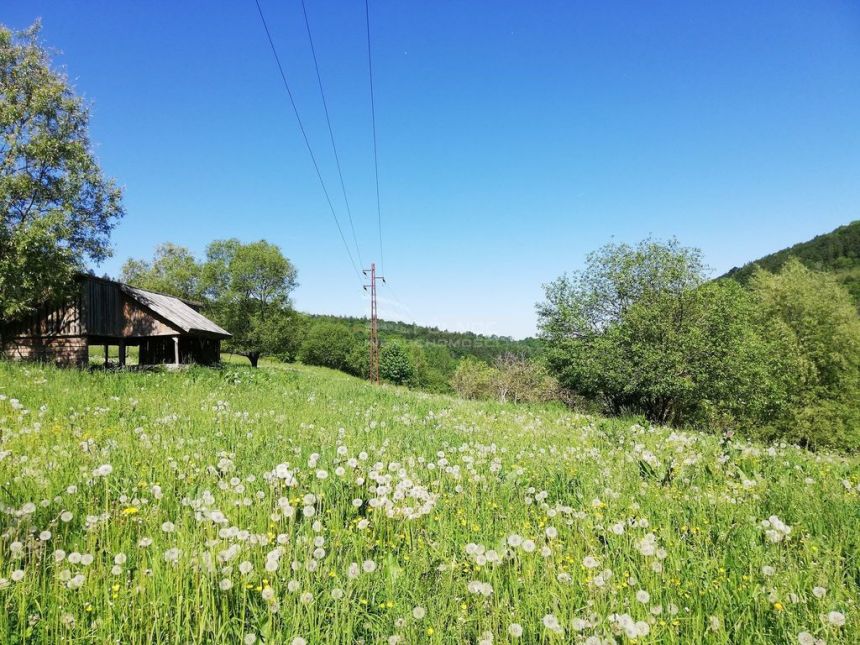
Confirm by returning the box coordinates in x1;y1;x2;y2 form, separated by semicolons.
539;240;798;427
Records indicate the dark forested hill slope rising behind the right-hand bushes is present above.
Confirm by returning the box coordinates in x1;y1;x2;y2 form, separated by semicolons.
726;220;860;306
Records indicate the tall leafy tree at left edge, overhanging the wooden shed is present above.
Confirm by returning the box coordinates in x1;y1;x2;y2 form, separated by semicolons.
0;23;124;318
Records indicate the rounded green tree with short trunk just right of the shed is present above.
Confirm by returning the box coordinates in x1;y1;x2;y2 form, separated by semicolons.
202;239;296;367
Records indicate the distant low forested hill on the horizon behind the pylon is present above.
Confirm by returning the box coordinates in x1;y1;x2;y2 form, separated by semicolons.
304;314;541;362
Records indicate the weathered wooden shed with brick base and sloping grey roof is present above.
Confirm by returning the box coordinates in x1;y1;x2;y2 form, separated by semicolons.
0;275;230;365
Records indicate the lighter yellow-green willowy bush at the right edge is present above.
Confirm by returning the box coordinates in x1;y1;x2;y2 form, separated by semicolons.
749;258;860;449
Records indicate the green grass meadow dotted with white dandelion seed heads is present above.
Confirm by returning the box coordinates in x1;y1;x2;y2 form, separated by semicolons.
0;363;860;644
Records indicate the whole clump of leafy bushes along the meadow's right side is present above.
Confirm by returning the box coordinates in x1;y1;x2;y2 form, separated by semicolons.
538;240;860;449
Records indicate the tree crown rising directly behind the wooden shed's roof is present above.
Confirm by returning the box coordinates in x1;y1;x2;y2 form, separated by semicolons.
121;242;203;300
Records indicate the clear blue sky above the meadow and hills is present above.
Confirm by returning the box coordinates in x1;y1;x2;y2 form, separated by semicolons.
0;0;860;336
